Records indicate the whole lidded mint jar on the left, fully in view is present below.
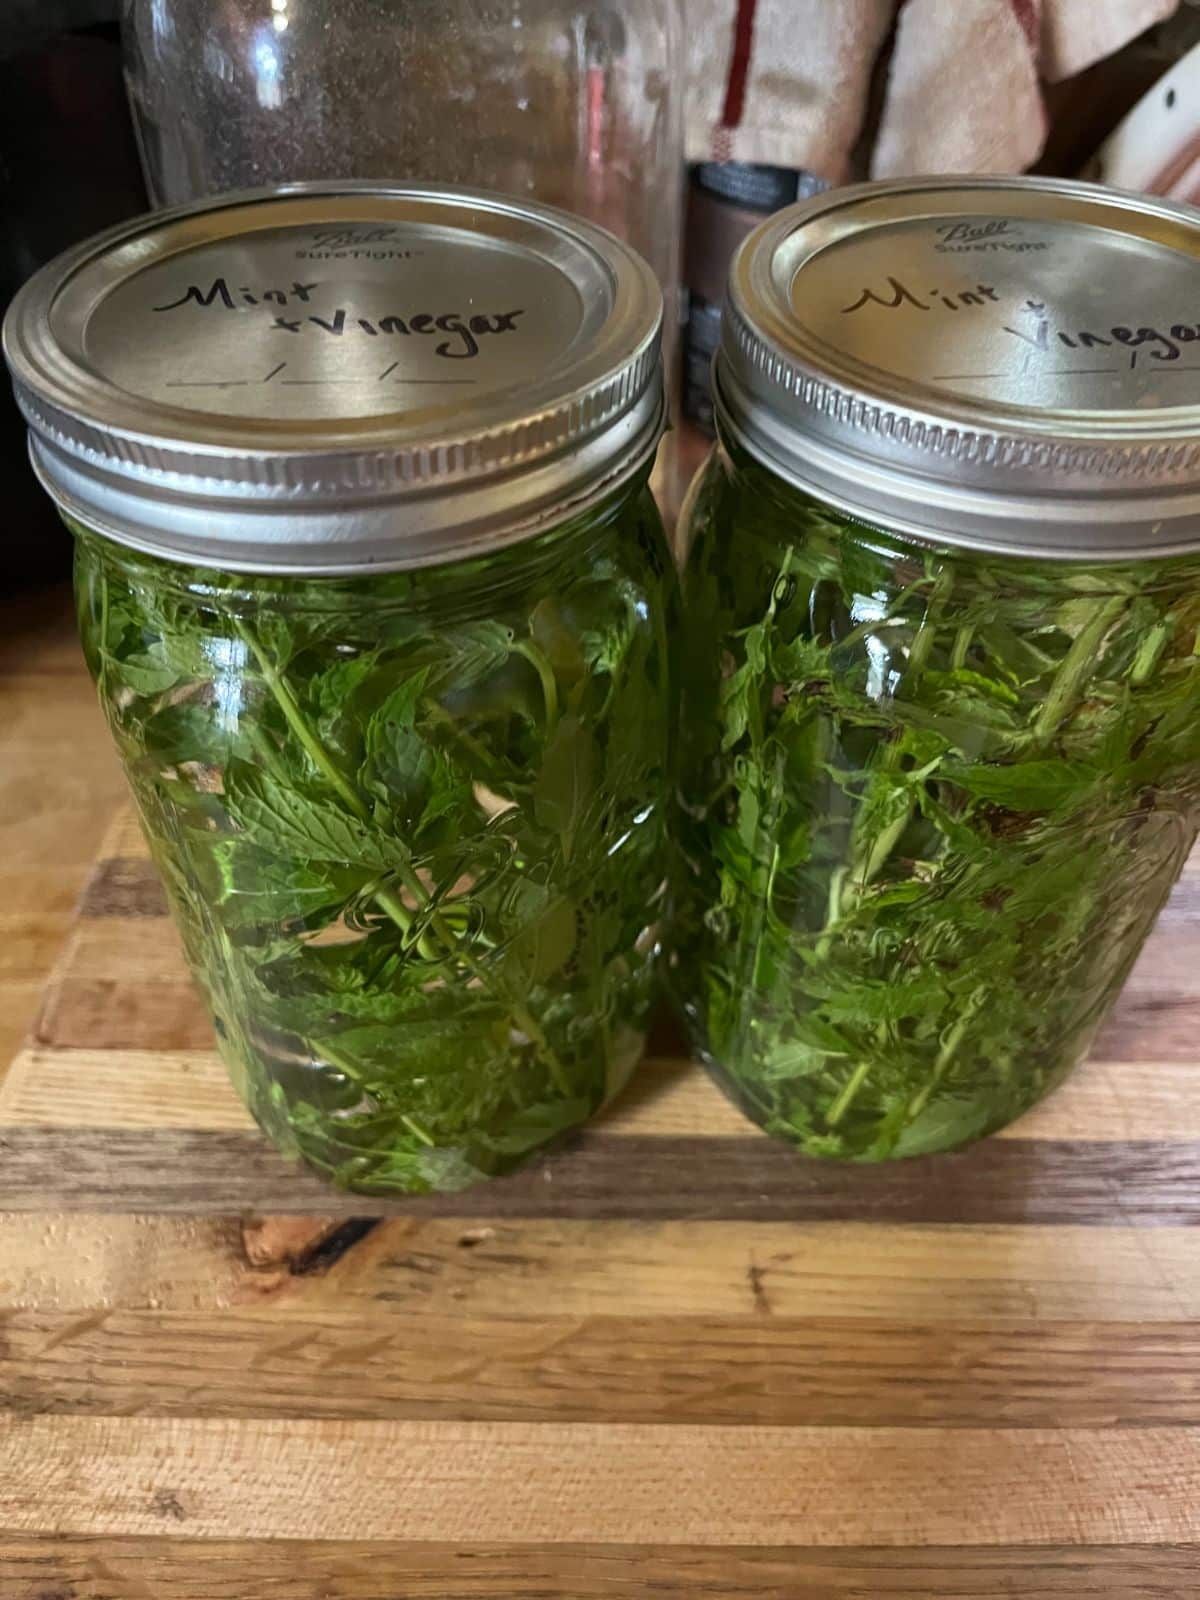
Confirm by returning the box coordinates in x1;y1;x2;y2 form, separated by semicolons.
5;186;674;1192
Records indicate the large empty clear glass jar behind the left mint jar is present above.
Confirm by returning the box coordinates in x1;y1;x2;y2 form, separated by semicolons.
125;0;683;328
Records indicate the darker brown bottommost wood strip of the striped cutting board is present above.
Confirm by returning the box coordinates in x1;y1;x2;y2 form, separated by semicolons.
9;1536;1197;1600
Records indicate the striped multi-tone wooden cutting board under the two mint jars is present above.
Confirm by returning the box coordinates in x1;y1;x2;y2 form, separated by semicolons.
0;818;1200;1600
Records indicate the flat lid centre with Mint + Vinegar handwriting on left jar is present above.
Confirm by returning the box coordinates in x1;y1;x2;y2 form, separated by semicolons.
85;224;588;419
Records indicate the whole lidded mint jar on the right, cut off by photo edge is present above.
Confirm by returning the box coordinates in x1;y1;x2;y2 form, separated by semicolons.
672;179;1200;1160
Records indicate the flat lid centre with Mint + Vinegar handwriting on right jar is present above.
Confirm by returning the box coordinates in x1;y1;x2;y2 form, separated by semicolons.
789;214;1200;413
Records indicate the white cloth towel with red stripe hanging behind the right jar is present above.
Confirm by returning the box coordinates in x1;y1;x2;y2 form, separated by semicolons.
685;0;1179;182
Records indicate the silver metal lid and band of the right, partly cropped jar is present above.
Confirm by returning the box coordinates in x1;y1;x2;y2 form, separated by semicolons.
715;178;1200;560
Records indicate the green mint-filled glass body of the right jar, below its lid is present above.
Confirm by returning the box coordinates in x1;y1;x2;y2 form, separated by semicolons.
674;456;1200;1160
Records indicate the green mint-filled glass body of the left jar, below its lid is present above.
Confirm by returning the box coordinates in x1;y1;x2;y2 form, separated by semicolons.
77;490;674;1190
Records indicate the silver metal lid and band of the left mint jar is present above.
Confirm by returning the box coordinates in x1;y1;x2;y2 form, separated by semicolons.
3;182;662;573
